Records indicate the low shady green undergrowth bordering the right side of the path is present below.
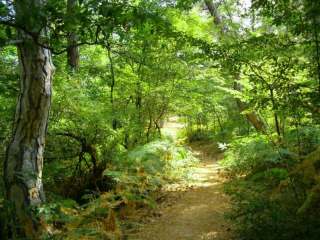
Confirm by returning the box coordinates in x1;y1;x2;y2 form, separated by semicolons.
221;129;320;240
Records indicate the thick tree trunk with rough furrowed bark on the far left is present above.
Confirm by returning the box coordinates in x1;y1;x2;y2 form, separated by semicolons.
4;0;54;239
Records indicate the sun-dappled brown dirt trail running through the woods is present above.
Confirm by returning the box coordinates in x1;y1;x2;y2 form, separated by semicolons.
129;118;231;240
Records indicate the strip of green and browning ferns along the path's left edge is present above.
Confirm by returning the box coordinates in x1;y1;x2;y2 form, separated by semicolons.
36;136;198;239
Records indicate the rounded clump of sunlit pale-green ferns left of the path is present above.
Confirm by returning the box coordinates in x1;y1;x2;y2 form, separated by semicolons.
104;140;197;197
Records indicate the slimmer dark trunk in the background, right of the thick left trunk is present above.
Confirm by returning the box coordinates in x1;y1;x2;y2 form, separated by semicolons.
67;0;79;71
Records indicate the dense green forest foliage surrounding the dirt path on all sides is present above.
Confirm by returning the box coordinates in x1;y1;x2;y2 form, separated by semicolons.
0;0;320;240
